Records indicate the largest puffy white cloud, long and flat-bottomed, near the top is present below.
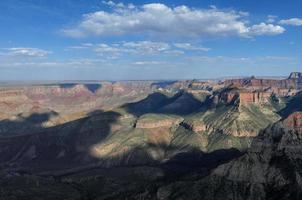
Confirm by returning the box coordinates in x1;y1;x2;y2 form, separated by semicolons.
62;1;284;37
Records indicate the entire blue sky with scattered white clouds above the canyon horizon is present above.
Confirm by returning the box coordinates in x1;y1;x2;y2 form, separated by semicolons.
0;0;302;81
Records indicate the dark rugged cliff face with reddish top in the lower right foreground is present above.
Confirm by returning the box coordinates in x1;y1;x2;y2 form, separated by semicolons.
170;112;302;200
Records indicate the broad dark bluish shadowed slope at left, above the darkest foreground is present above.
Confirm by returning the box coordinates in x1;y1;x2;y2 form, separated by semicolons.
0;111;120;171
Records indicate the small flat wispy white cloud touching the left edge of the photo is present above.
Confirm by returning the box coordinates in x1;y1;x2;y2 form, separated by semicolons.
1;47;51;57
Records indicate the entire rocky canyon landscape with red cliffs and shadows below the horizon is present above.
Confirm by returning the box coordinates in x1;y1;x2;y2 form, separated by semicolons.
0;72;302;199
